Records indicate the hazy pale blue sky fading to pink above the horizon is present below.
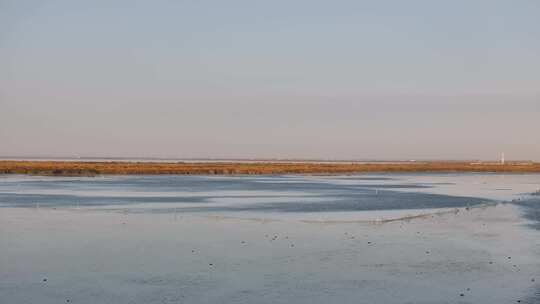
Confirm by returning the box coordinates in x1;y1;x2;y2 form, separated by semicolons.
0;0;540;161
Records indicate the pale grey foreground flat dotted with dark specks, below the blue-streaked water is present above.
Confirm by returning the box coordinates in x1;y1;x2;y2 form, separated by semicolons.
0;205;540;304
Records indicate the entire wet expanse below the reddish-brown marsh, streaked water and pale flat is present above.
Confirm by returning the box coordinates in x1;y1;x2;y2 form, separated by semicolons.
0;174;540;303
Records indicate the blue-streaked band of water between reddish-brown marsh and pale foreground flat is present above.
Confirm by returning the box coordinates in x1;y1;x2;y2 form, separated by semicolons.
0;174;540;221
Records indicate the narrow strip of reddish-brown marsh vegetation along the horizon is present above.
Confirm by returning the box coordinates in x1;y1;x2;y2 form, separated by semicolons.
0;160;540;176
